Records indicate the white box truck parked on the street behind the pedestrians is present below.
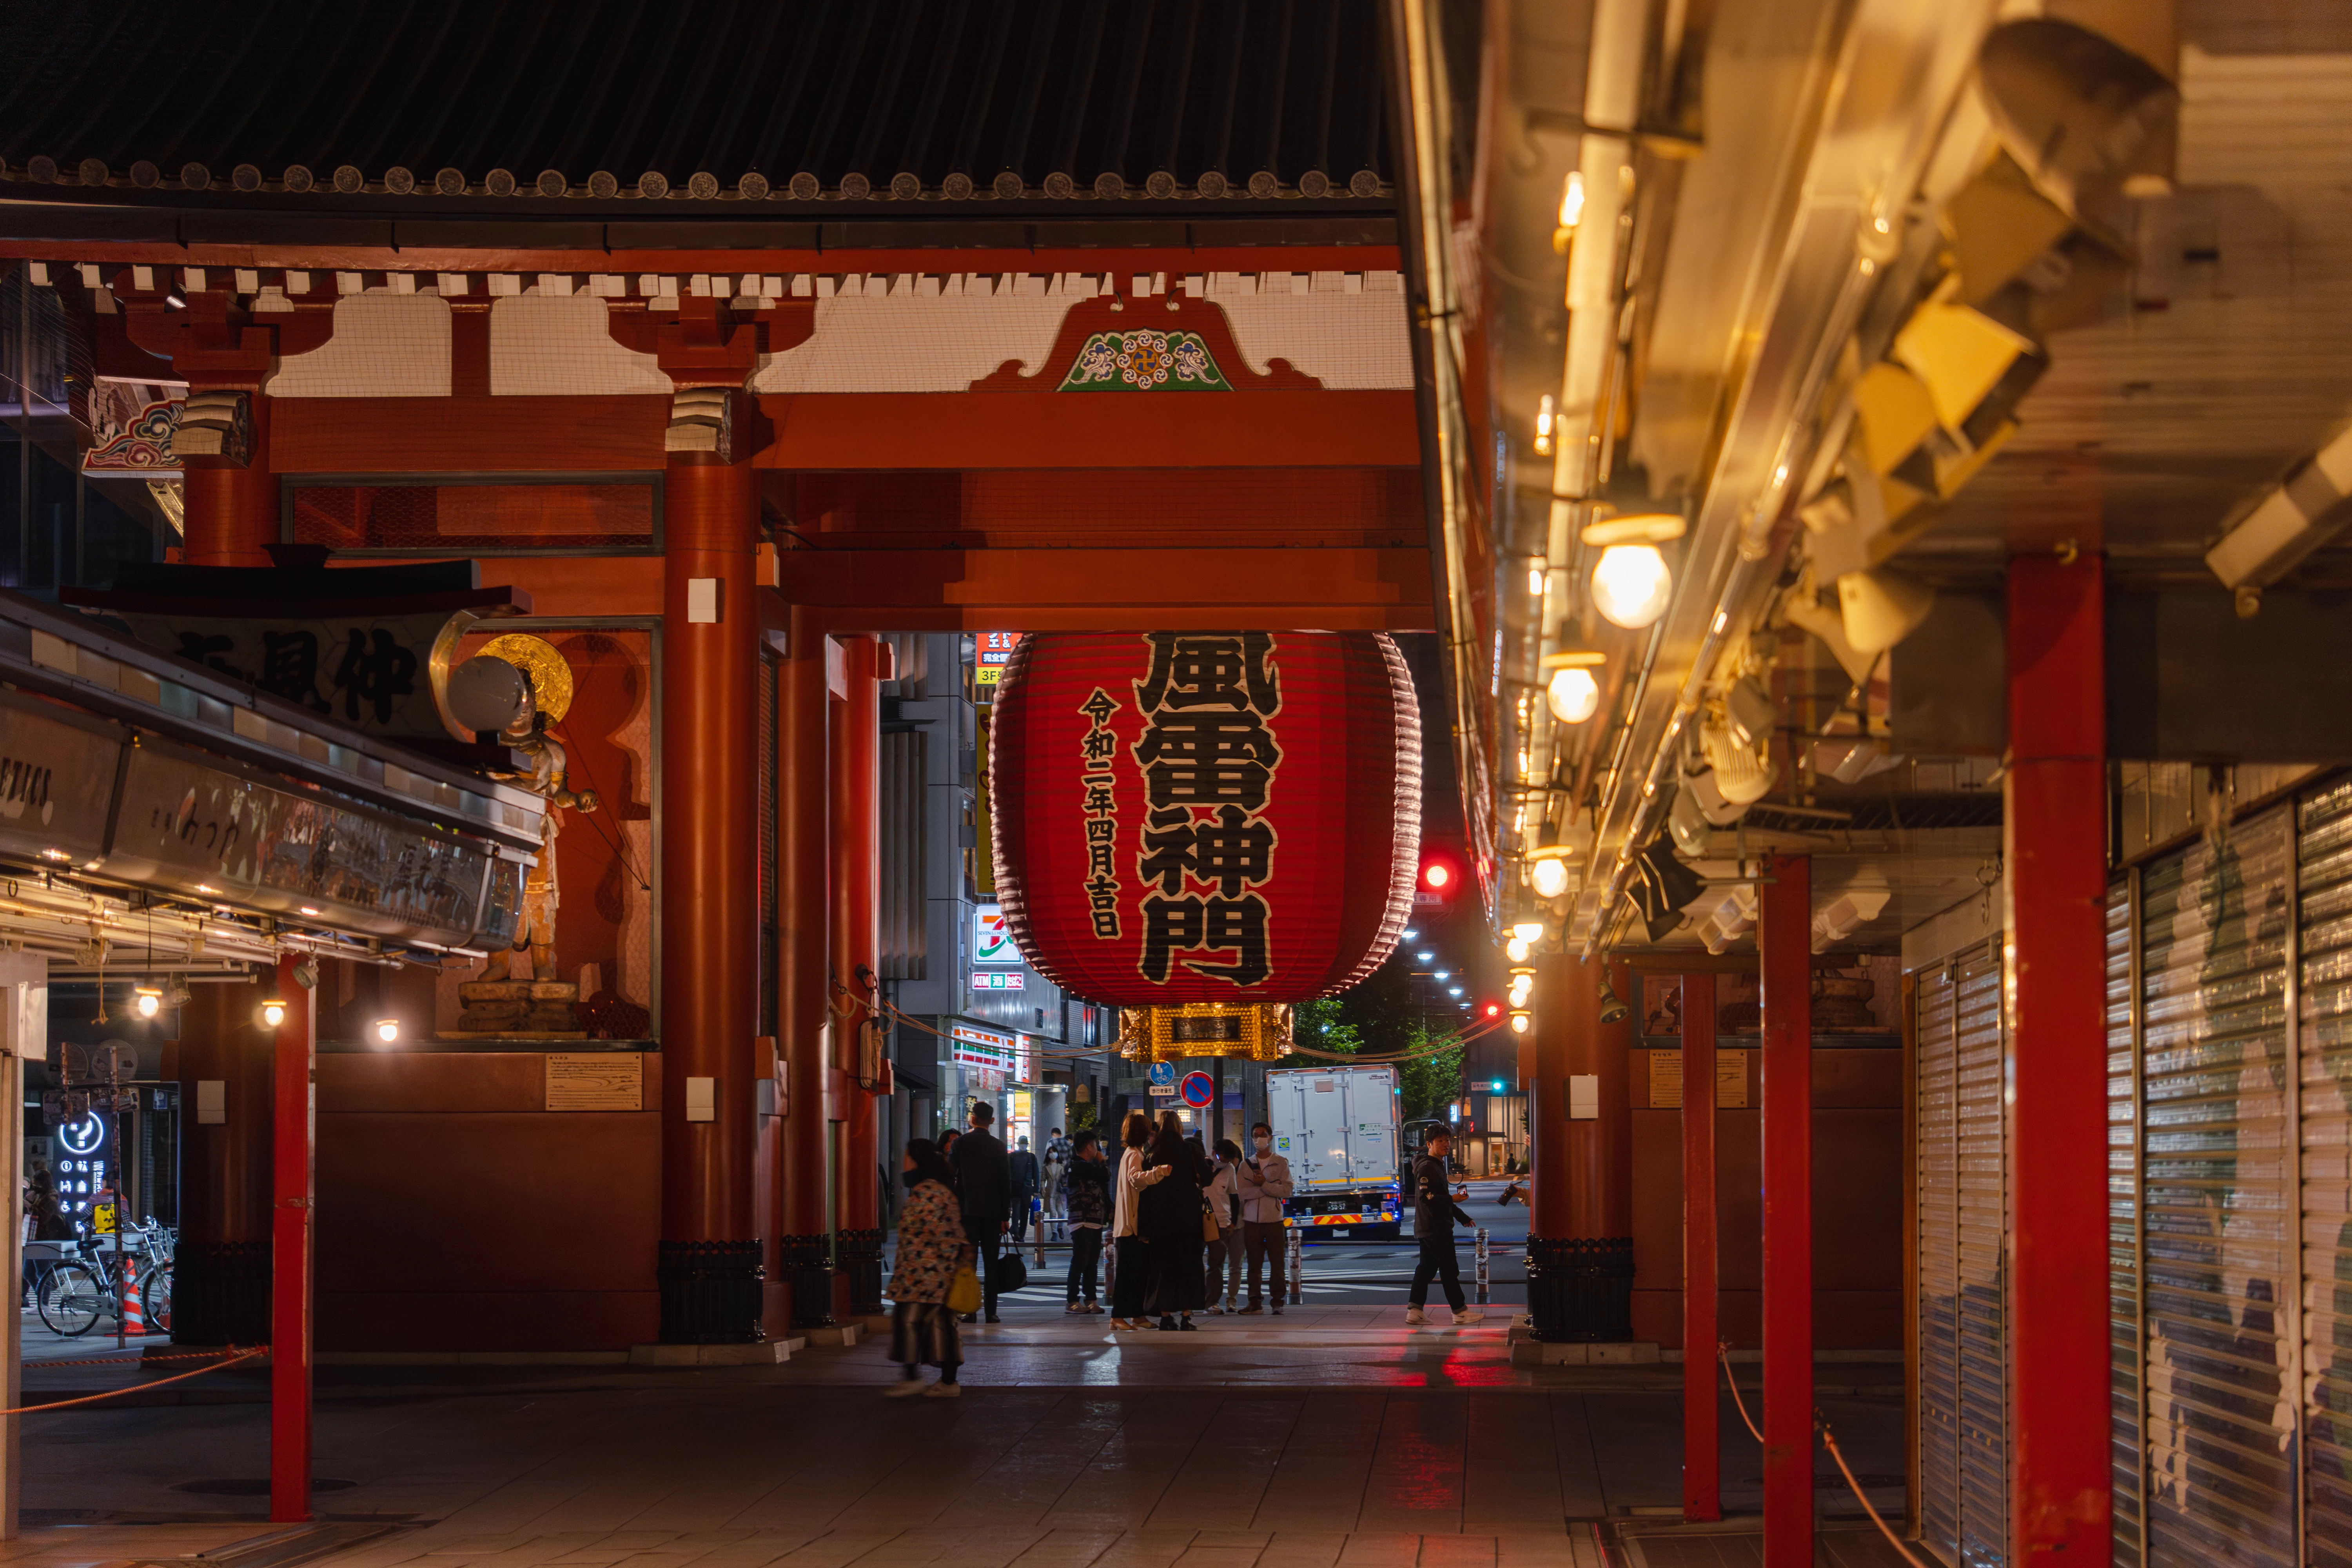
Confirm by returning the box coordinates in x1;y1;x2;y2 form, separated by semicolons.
1265;1063;1399;1241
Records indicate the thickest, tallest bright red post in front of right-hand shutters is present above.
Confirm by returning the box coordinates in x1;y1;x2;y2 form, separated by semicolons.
2002;555;2112;1563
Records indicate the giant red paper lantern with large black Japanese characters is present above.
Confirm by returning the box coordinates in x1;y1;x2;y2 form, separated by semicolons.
988;632;1421;1009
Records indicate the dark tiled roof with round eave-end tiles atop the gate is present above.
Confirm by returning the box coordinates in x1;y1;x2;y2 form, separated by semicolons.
0;0;1388;205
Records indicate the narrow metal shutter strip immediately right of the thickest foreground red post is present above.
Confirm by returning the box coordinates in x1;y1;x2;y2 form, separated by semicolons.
2107;884;2145;1563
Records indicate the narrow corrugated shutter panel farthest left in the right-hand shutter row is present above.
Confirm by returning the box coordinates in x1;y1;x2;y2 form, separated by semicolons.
1917;969;1959;1563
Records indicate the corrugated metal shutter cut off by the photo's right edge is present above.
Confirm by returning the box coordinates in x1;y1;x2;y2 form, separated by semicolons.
2296;785;2352;1566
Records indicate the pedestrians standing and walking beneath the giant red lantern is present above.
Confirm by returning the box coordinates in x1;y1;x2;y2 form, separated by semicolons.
887;1100;1484;1399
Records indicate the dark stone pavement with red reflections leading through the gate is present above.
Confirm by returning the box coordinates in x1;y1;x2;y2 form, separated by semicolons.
0;1307;1903;1568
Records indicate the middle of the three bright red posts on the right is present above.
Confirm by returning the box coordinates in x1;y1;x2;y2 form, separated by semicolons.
1759;856;1813;1568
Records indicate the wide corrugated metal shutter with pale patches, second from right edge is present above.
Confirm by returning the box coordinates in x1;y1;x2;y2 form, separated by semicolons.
2140;811;2300;1568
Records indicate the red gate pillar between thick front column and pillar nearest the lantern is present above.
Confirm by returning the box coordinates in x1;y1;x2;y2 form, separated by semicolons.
776;606;840;1328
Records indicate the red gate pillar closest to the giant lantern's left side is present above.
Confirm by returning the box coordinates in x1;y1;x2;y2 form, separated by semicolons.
826;637;889;1316
